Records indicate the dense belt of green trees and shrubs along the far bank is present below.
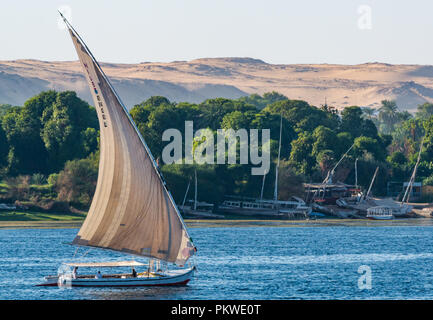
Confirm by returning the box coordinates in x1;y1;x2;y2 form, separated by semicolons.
0;91;433;208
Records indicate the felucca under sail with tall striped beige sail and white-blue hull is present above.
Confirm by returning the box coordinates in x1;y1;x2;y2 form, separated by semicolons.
38;13;197;286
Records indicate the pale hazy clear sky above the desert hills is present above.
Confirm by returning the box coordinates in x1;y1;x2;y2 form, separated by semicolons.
0;0;433;64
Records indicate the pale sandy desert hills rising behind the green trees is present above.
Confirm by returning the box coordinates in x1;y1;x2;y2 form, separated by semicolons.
0;58;433;111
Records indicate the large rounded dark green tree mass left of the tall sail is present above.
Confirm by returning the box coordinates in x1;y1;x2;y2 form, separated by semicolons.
1;90;98;175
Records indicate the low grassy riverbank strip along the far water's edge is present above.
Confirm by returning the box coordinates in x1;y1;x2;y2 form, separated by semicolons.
0;218;433;229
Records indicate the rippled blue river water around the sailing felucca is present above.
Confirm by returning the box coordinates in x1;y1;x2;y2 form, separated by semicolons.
0;225;433;299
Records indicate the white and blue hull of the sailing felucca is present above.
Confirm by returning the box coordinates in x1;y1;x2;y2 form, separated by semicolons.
37;267;195;287
